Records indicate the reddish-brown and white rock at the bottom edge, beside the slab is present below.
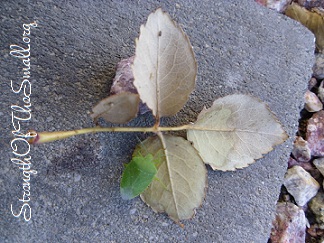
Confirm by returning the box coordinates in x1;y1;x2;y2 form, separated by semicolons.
270;202;306;243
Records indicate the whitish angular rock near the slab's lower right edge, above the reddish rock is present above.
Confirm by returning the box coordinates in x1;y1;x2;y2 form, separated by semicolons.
283;165;320;206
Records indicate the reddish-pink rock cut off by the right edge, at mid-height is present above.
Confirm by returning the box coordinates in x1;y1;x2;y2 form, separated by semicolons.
306;110;324;157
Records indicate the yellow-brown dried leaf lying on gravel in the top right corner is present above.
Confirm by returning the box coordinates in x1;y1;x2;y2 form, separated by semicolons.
285;3;324;52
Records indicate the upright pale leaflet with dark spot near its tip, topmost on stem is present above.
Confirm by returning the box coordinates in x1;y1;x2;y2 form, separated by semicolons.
133;9;197;118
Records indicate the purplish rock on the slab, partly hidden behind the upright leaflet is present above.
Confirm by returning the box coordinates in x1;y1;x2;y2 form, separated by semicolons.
110;56;150;115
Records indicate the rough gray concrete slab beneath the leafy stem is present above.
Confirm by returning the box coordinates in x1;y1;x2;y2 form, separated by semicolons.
0;0;314;243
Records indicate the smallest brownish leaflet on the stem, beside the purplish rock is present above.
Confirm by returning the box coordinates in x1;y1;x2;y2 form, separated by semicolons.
91;92;140;123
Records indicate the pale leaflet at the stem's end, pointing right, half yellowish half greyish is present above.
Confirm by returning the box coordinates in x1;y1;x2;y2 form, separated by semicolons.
187;94;287;171
